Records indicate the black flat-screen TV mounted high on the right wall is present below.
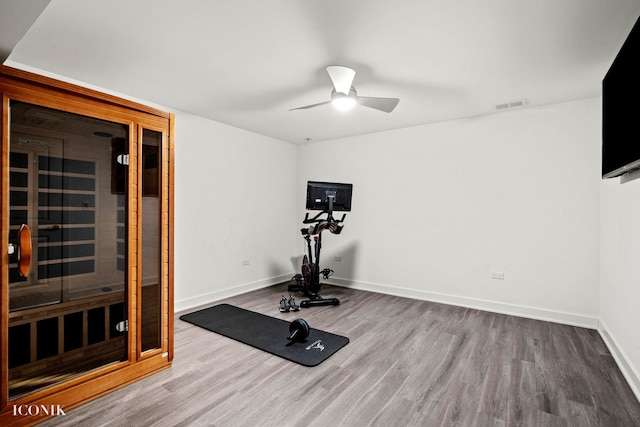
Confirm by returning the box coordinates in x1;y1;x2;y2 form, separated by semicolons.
602;14;640;178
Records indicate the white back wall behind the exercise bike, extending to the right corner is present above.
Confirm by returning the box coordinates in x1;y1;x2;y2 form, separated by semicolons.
298;98;601;327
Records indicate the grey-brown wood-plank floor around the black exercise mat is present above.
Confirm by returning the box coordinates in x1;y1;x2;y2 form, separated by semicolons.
42;285;640;427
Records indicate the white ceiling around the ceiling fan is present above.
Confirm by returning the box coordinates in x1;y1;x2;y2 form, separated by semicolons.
0;0;640;143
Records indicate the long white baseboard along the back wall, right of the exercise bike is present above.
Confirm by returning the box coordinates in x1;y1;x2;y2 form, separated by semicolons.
325;277;599;329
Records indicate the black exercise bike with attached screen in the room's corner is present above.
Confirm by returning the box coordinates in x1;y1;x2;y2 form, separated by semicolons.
288;181;352;308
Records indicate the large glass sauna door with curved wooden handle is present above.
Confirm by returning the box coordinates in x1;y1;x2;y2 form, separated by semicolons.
8;101;129;398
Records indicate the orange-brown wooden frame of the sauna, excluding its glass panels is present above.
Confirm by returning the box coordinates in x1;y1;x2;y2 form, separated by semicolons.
0;65;174;426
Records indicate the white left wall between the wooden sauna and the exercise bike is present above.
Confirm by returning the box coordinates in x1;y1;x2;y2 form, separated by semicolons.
174;112;297;311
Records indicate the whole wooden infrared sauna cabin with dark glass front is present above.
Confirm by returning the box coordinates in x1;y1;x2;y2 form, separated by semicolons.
0;66;174;426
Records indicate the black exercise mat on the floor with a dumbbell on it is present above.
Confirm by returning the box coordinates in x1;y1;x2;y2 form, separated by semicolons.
180;304;349;366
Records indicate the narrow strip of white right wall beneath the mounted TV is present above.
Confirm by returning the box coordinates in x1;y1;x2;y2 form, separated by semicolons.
600;173;640;399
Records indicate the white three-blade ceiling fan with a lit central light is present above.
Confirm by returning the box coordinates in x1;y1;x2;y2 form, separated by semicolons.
289;65;400;113
